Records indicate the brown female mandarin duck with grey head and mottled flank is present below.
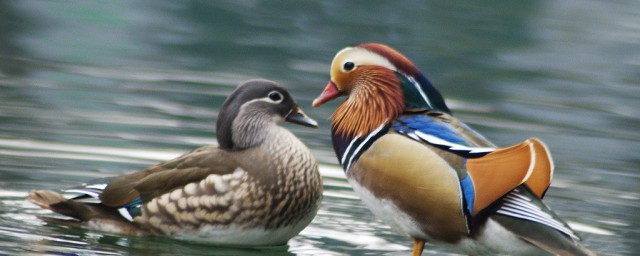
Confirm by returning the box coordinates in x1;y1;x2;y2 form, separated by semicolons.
28;80;322;245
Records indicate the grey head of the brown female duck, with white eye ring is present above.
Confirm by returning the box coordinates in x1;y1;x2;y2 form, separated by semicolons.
216;79;318;150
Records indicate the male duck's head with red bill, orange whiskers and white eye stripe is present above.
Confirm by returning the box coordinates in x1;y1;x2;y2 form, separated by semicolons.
312;43;449;136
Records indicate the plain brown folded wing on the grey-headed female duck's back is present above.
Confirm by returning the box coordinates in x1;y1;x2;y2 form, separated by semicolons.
100;146;237;207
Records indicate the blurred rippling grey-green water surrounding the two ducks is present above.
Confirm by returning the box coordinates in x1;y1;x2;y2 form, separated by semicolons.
0;0;640;255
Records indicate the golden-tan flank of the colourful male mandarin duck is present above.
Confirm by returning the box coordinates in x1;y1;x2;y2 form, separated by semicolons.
338;134;468;242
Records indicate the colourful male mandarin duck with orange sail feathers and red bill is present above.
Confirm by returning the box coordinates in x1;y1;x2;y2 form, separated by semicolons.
313;43;593;255
